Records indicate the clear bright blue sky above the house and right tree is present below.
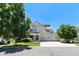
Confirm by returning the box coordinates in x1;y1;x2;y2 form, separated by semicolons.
24;3;79;30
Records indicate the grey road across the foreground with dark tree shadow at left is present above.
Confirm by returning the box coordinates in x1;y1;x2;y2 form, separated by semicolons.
0;47;79;56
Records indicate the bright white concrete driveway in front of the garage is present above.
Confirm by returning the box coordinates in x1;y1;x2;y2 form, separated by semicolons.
40;42;76;47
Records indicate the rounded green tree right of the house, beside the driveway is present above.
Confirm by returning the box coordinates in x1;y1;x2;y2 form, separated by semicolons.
57;24;77;43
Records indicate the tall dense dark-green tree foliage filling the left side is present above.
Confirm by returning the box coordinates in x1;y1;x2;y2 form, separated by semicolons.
0;3;31;44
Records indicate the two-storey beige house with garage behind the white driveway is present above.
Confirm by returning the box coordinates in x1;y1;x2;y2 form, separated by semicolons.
30;22;58;41
